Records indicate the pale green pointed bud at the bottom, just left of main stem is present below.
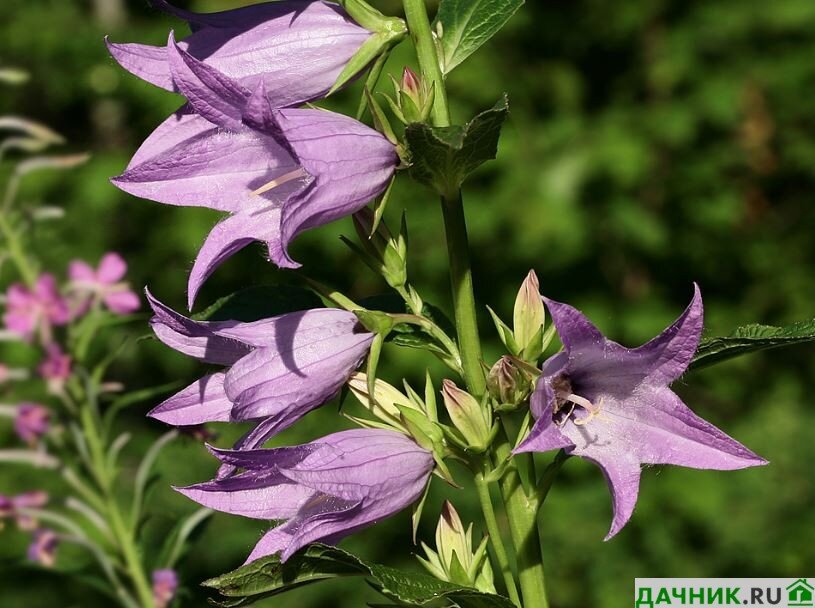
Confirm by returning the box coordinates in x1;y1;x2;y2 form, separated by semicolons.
419;501;495;593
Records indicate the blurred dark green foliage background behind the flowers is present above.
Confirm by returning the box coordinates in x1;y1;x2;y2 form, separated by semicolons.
0;0;815;608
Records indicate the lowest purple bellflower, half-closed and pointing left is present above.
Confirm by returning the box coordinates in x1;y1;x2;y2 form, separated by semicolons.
179;429;434;562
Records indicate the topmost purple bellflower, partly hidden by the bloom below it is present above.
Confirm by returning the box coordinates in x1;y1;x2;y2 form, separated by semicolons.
108;0;371;108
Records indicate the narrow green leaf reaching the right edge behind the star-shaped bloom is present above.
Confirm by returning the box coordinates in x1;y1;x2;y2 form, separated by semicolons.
691;319;815;369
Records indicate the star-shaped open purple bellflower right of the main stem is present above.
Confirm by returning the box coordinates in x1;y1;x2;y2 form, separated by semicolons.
516;287;767;540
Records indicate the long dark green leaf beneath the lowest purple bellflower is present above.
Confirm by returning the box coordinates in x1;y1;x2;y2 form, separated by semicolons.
203;544;513;608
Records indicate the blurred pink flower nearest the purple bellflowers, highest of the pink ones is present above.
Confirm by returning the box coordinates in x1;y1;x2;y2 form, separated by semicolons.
68;252;140;315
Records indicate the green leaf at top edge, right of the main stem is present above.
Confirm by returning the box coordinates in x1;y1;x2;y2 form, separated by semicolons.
433;0;524;74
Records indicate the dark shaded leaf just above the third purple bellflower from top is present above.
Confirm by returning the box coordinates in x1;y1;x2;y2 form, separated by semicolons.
192;285;323;323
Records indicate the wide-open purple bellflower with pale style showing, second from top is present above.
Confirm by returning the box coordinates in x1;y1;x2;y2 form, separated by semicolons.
112;34;398;307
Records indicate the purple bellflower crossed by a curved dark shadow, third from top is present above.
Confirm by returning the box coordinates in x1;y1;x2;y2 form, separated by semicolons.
147;292;373;447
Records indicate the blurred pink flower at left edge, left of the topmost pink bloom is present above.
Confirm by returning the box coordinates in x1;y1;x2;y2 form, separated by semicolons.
3;273;71;343
